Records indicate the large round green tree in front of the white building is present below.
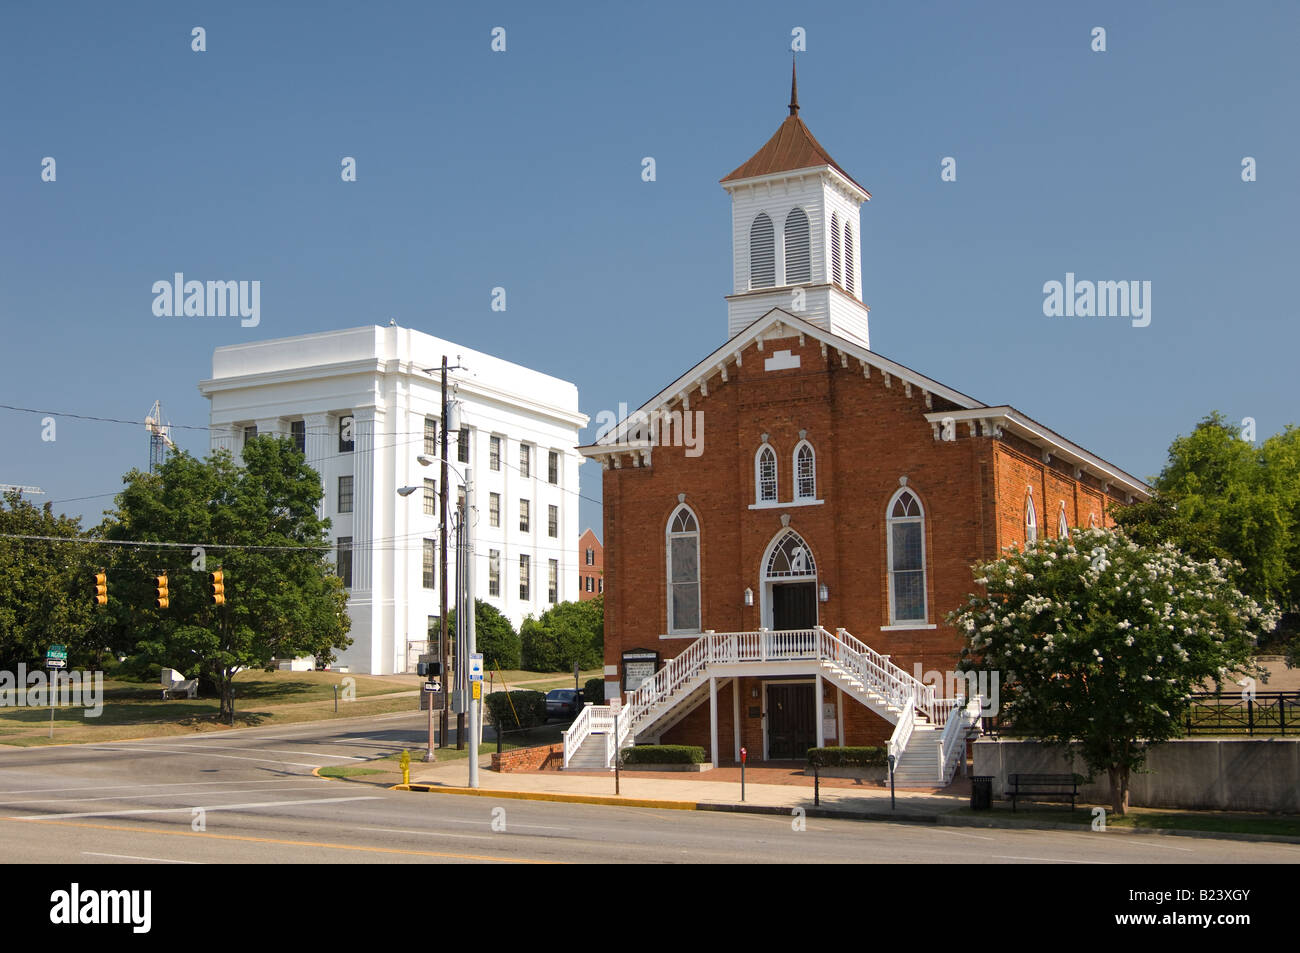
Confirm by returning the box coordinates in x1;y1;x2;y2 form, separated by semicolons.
101;436;351;723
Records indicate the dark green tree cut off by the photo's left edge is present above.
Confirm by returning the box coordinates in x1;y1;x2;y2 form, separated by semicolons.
0;493;105;670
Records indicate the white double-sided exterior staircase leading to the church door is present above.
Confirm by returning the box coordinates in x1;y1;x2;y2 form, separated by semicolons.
564;625;980;787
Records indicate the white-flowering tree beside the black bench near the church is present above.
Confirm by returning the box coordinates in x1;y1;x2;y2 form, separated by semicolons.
948;529;1278;814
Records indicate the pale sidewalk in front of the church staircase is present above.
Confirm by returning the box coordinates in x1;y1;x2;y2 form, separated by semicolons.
399;758;970;820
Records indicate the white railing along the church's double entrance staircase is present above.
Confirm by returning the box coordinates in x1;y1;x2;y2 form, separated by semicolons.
564;625;956;767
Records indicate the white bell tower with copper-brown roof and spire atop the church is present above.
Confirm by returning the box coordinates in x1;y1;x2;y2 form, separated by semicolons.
722;70;871;347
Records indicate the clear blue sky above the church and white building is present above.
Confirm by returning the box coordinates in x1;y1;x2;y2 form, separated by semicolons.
0;1;1300;532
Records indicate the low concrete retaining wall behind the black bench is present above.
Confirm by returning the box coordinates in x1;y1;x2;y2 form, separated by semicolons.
974;738;1300;814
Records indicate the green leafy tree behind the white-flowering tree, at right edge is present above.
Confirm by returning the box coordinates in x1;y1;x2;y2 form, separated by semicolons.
1113;412;1300;664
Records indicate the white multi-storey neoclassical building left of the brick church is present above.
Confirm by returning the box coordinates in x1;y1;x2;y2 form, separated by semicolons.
199;325;588;675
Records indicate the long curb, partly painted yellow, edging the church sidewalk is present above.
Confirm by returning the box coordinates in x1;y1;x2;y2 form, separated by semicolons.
387;783;1300;844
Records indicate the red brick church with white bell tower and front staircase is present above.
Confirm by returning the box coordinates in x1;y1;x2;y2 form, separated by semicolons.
566;68;1148;783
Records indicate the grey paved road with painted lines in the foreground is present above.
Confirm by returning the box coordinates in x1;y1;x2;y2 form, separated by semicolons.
0;714;1300;865
